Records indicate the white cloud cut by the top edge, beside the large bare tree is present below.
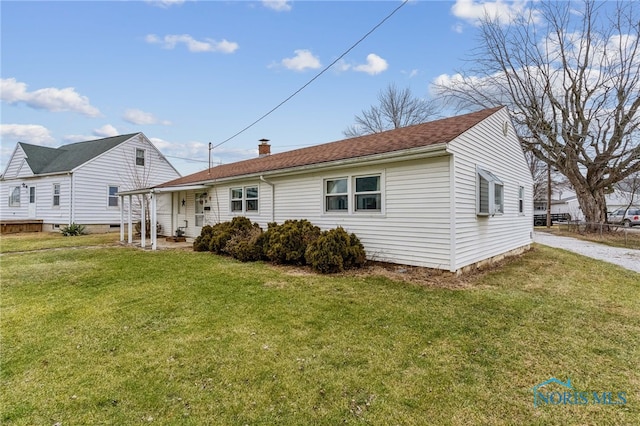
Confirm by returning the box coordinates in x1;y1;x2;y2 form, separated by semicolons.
451;0;529;28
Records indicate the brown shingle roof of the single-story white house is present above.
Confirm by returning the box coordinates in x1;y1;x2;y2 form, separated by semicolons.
160;107;503;187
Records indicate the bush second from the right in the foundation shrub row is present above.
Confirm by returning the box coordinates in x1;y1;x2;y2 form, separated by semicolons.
263;219;320;265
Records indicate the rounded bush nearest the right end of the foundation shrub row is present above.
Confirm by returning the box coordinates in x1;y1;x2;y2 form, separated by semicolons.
305;227;366;274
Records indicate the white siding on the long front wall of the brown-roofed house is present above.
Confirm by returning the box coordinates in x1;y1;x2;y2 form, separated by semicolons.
187;160;451;269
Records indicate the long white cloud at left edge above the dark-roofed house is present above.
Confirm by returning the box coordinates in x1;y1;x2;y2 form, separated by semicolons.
0;78;100;117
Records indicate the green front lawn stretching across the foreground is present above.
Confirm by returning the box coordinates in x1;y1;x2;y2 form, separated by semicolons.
0;235;640;425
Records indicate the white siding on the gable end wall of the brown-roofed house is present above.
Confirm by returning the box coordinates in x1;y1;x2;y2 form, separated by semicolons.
449;109;533;269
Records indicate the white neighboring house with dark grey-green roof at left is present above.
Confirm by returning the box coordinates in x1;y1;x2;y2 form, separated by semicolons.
0;133;180;233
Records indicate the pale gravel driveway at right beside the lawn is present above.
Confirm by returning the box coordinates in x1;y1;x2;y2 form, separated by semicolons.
533;232;640;272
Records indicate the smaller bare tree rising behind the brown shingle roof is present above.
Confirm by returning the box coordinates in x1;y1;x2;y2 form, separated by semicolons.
342;84;438;137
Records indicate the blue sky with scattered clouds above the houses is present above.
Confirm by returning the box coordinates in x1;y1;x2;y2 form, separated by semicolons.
0;0;528;175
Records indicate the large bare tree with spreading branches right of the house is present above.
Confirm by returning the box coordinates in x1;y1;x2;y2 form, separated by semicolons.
434;0;640;230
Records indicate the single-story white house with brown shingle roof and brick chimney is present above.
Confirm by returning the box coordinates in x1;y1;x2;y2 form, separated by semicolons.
122;108;533;271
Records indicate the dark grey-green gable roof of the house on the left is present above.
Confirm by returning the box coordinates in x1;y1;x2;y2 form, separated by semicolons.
18;133;138;175
